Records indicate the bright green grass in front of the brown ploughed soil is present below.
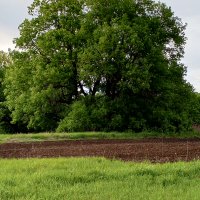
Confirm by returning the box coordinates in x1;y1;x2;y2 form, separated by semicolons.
0;158;200;200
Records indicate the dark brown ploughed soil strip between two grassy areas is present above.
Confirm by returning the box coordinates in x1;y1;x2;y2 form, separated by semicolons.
0;139;200;162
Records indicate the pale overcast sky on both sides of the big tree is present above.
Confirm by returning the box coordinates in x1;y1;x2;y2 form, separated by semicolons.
0;0;200;92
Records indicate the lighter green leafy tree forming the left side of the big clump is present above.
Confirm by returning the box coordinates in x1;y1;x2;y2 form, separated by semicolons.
5;0;83;130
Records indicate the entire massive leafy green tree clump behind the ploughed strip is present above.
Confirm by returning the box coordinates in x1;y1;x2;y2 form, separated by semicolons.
5;0;196;131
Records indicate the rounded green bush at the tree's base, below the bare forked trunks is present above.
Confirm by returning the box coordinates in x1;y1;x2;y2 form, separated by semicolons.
57;98;108;132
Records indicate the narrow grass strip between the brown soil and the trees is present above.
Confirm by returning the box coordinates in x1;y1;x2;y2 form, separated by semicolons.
0;131;200;143
